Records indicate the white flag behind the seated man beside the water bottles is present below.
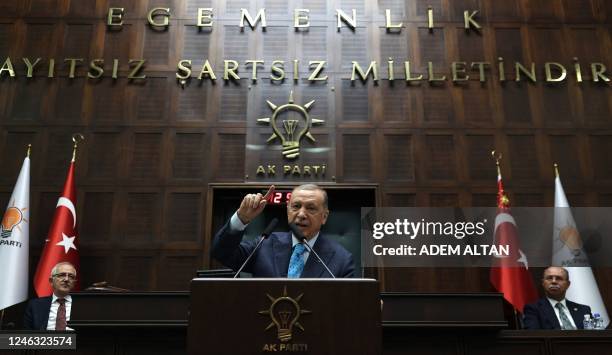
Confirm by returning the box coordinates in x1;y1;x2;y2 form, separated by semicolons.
553;176;610;326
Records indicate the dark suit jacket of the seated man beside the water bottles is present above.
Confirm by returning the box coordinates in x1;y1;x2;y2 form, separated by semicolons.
523;298;591;329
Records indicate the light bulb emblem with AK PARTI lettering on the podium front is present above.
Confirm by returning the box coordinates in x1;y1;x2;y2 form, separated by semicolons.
258;286;312;351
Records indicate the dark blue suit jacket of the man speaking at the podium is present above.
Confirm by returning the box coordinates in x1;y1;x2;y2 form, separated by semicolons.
212;222;355;278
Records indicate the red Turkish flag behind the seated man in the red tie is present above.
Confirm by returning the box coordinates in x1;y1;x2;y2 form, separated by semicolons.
34;162;80;297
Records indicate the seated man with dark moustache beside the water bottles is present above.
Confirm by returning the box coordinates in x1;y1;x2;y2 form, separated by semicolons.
523;266;591;330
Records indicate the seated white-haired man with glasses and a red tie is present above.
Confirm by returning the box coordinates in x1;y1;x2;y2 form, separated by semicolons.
23;262;77;330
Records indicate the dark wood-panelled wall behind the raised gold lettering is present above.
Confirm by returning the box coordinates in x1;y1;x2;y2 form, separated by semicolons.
0;0;612;297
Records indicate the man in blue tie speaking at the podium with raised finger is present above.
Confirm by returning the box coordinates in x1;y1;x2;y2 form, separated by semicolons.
212;184;355;278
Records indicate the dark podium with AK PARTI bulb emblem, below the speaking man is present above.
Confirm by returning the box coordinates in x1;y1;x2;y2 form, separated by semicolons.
187;279;382;355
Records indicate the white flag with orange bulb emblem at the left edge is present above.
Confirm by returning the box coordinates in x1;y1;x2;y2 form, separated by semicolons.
0;157;30;309
